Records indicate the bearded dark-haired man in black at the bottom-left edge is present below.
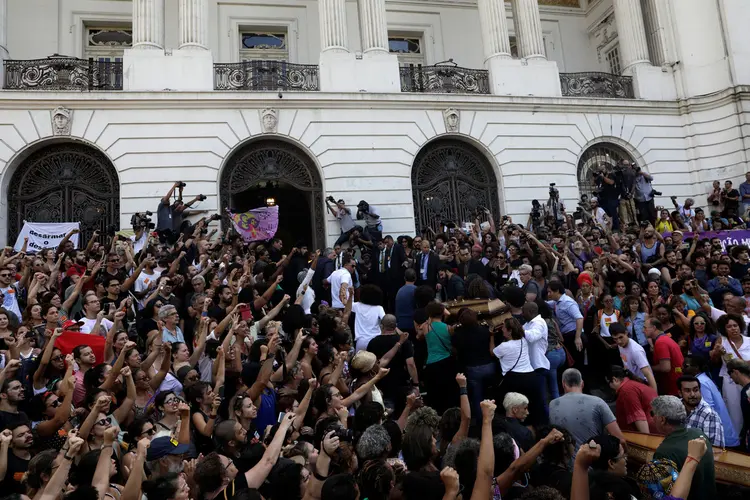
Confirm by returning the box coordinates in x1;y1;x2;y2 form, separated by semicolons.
0;422;34;495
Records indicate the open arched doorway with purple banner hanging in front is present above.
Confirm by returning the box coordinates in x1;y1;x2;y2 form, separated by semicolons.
219;139;326;250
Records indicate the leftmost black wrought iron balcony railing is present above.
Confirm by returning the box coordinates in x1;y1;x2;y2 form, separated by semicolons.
4;56;122;91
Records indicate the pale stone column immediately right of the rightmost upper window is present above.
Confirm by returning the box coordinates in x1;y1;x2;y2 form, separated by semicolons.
614;0;651;75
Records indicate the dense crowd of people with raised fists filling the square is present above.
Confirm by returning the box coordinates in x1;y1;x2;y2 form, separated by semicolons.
0;172;750;500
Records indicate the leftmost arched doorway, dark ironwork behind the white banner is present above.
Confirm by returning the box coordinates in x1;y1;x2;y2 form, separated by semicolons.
8;143;120;245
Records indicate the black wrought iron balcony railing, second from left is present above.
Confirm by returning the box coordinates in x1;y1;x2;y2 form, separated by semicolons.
214;60;320;92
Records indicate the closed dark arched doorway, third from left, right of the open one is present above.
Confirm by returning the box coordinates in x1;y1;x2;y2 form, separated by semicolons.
411;139;499;232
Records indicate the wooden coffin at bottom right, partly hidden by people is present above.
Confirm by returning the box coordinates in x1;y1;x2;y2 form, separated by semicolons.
623;431;750;487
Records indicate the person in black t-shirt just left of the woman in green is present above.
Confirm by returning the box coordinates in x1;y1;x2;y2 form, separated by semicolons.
367;314;419;415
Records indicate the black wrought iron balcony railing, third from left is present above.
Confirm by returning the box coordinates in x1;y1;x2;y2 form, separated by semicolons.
400;60;490;94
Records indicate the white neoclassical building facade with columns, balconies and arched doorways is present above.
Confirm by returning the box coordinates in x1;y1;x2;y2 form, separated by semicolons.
0;0;750;246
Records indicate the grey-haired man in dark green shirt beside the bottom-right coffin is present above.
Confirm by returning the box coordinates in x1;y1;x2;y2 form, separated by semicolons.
651;396;716;500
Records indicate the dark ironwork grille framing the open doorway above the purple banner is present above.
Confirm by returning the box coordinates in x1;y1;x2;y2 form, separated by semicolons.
219;140;326;248
